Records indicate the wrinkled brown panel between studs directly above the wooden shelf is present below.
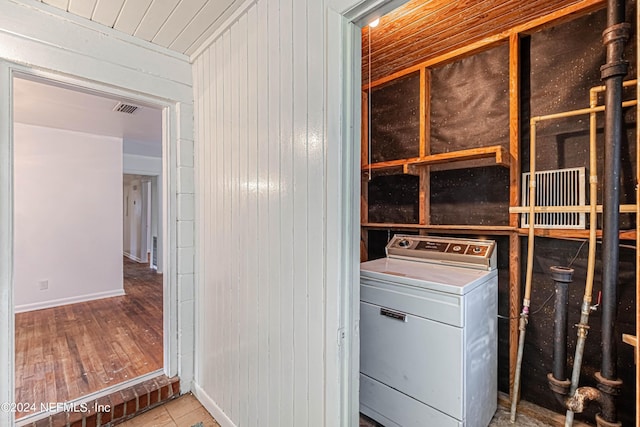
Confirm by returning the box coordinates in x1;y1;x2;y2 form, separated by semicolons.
431;45;509;154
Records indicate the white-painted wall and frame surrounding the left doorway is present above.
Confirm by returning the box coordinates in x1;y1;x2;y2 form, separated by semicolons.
0;1;194;427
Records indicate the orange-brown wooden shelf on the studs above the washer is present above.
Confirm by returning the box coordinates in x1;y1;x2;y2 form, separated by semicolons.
362;145;509;175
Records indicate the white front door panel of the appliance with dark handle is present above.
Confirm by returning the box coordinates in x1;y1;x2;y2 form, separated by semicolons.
360;302;464;420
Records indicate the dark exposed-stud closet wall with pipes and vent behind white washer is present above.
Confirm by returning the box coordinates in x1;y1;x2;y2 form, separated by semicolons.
361;0;638;427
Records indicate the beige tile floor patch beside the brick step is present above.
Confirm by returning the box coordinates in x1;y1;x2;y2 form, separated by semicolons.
118;394;220;427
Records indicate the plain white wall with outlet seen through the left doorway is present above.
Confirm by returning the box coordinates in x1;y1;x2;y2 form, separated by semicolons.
14;123;124;312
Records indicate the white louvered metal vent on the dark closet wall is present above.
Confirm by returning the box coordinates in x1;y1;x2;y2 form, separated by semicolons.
520;167;586;229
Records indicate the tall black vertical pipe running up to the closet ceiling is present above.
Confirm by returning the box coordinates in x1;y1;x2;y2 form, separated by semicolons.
601;0;629;379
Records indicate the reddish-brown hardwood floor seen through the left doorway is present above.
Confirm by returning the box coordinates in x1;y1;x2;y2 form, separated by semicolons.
15;258;163;417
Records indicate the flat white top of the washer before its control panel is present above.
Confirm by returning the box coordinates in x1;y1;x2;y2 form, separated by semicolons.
360;258;497;295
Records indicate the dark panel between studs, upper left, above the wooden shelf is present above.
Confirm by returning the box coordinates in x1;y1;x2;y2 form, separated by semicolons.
369;72;420;163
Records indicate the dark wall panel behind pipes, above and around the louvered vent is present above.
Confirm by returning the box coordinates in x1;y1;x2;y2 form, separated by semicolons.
521;2;636;229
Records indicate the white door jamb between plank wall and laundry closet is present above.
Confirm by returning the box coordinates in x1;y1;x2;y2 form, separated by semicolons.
325;0;408;426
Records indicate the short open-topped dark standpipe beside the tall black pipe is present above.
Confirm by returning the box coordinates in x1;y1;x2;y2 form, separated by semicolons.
551;266;573;381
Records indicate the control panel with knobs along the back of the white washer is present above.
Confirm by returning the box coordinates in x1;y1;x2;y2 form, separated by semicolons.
386;234;496;270
